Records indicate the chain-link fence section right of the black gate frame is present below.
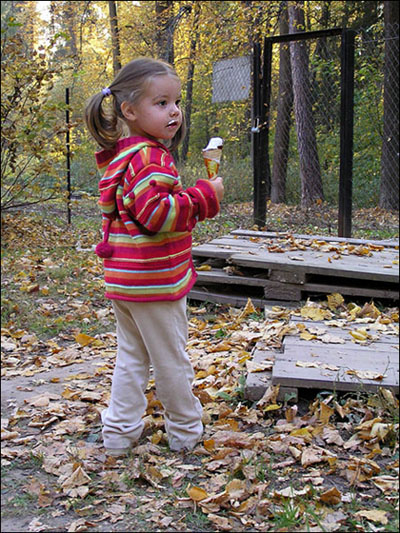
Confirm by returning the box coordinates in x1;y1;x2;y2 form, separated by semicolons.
353;24;399;210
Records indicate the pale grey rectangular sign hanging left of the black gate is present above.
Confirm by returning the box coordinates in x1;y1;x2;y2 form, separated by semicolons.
212;56;251;103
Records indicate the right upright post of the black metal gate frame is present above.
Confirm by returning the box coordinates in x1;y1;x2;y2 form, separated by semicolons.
338;29;356;237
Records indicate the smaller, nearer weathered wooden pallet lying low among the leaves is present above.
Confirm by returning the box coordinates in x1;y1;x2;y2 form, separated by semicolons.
246;319;399;401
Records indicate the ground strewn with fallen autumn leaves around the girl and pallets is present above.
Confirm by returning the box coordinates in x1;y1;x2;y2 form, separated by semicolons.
2;206;399;531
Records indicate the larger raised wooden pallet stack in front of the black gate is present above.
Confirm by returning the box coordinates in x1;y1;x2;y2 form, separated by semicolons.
190;231;399;305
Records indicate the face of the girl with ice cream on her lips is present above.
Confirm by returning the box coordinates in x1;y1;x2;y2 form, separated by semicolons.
121;75;182;140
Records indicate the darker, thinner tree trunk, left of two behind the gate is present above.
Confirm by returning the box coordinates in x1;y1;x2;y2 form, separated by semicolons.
271;2;293;204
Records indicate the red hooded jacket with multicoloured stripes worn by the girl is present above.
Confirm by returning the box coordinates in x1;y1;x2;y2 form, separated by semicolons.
96;137;219;302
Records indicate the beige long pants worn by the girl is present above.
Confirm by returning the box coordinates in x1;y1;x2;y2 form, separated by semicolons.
102;298;203;450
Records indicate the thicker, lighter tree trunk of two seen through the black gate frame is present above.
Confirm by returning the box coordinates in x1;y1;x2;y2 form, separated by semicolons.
289;1;323;207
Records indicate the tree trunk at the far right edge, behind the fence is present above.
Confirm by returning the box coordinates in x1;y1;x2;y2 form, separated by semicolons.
379;1;399;210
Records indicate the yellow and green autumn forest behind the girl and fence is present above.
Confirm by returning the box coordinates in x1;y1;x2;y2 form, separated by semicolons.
1;1;398;237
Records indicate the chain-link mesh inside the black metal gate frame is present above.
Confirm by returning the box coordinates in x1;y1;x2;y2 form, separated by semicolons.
270;30;341;207
